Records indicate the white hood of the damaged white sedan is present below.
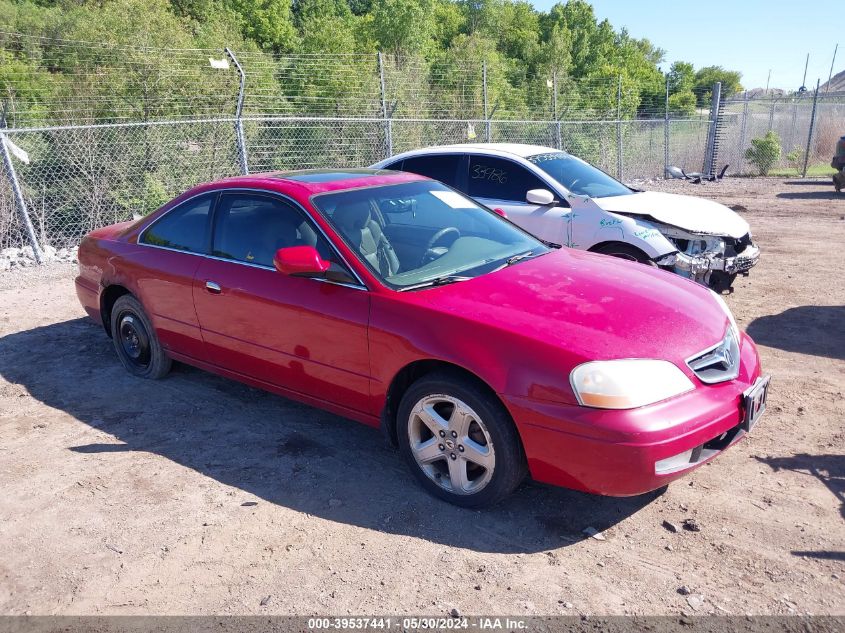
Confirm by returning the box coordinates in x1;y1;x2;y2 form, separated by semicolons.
593;191;748;238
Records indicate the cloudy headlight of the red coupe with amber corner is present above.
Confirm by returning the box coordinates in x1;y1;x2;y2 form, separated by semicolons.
569;359;694;409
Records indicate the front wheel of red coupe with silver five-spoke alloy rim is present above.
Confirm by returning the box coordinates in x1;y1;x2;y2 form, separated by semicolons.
397;373;527;508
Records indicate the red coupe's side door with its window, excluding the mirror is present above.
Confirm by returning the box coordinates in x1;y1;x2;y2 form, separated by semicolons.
194;192;370;412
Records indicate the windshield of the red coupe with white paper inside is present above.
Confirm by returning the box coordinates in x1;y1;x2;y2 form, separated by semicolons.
311;181;549;290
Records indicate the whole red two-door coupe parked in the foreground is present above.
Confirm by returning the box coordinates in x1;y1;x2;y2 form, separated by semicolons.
76;170;768;507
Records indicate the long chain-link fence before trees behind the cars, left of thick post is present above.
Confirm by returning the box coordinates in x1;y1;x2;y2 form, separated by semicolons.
0;33;711;260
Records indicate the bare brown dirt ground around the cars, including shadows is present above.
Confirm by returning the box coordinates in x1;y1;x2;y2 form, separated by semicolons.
0;179;845;615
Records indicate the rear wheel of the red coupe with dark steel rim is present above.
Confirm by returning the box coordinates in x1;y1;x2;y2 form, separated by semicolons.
111;295;172;380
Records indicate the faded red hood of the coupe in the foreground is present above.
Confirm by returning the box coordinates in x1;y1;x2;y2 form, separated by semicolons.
417;249;728;371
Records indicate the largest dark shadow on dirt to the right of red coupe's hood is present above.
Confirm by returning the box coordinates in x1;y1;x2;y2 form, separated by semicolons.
747;306;845;360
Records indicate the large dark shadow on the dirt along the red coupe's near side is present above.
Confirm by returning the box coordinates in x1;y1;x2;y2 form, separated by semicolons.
0;319;661;553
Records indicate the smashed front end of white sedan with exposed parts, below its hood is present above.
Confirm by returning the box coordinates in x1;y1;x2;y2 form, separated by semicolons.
653;222;760;293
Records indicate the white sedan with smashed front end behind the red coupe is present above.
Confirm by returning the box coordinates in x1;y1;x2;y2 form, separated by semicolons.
373;143;760;292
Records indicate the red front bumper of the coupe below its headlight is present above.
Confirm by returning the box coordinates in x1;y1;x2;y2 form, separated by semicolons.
503;328;760;496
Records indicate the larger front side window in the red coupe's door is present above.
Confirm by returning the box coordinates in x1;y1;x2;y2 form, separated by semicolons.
212;193;333;268
